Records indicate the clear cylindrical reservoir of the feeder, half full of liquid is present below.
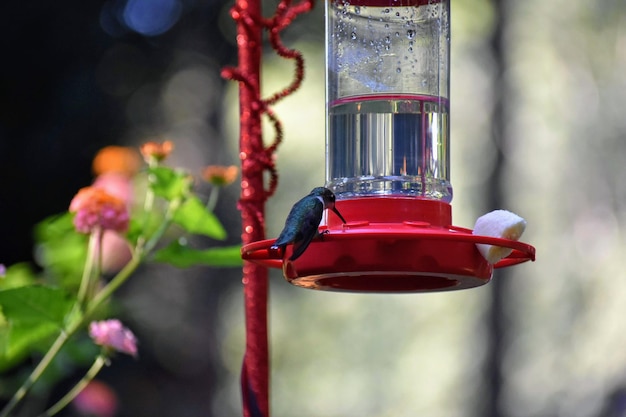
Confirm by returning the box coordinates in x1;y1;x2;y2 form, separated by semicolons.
326;0;452;202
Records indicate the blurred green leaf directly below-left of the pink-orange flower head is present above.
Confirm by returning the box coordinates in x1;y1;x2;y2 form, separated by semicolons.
35;213;88;289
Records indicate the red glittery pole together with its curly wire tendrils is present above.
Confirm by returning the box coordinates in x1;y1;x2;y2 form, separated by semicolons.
222;0;313;417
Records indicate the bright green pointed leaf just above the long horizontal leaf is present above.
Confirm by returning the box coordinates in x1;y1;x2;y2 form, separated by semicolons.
173;196;226;240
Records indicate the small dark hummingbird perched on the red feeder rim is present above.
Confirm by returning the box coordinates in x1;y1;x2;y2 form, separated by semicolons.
271;187;346;261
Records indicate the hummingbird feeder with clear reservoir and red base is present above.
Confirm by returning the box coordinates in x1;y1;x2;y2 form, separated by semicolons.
242;0;535;293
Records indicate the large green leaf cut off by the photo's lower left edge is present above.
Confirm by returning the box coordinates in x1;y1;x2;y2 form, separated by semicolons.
0;285;75;370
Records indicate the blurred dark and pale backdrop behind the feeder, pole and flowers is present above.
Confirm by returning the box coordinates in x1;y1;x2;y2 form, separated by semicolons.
0;0;626;417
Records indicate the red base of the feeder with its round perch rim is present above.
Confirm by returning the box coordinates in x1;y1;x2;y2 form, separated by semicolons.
242;197;535;293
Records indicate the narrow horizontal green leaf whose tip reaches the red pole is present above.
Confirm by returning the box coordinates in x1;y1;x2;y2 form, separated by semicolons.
154;241;243;268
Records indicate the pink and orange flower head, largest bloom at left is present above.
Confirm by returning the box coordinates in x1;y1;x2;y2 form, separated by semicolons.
70;187;129;233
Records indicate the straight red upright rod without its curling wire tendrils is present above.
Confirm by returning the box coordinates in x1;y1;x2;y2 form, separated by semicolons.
233;0;269;417
